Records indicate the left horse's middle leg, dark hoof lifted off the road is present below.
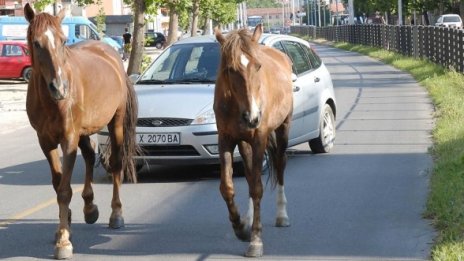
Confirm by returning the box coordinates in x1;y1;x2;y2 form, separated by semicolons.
79;136;98;224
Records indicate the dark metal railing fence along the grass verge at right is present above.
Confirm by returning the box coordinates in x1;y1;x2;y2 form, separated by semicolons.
291;24;464;73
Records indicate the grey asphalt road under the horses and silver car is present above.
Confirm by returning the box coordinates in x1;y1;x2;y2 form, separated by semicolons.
0;45;435;260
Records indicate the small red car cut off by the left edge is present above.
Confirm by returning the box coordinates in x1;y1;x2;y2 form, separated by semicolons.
0;41;32;82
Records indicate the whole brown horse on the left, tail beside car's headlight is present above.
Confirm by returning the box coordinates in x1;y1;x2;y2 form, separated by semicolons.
24;4;138;259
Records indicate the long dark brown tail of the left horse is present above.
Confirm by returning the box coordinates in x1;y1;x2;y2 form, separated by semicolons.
121;76;141;183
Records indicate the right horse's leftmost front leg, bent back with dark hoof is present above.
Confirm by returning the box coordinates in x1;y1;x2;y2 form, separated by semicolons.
219;138;246;241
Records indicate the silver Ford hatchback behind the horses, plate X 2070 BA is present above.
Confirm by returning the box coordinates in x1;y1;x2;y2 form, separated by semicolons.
97;34;336;169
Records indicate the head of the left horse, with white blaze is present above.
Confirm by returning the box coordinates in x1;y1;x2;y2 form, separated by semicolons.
24;3;68;100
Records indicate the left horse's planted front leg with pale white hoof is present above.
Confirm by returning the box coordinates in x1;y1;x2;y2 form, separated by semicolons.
55;137;79;259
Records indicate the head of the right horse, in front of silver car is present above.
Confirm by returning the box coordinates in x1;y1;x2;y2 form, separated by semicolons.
215;24;264;129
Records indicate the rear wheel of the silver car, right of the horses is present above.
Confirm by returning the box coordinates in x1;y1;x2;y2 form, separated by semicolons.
309;104;335;153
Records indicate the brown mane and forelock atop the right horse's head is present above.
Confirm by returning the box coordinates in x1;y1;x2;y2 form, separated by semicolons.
221;28;257;71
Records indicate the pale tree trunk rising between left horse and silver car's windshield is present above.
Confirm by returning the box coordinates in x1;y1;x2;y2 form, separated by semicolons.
127;0;146;75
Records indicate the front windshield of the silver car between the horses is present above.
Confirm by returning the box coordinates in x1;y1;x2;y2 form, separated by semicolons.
139;43;220;84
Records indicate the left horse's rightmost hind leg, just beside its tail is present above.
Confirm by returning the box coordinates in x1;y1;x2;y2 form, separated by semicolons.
108;118;124;229
